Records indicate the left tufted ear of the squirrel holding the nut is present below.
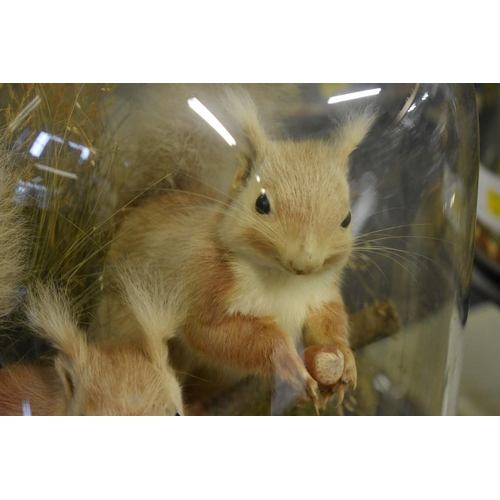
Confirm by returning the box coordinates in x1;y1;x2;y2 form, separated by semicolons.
222;87;267;189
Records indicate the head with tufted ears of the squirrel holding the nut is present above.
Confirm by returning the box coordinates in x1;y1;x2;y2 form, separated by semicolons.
220;93;374;275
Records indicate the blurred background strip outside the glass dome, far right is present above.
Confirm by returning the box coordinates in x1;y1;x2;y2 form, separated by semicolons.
458;83;500;415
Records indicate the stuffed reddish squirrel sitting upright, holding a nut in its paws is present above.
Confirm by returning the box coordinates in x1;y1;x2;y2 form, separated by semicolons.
93;89;374;412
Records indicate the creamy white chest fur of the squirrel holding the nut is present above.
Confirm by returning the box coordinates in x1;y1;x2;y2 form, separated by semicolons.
228;260;339;343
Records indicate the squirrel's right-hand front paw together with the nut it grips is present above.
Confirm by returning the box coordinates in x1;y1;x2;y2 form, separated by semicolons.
304;345;357;406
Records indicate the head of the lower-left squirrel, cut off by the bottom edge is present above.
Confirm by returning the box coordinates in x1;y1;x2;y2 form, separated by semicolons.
27;285;183;415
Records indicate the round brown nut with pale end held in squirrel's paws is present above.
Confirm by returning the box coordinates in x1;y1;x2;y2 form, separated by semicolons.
304;345;344;387
